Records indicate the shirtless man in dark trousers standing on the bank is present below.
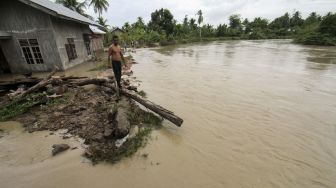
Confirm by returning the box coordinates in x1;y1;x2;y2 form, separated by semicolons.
108;36;125;89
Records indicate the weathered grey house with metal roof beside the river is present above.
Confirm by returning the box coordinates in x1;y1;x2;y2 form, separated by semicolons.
0;0;100;73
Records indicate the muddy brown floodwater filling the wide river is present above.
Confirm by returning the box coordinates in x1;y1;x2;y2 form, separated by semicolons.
0;40;336;188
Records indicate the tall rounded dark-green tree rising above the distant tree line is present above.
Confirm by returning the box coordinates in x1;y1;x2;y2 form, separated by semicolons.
148;8;175;37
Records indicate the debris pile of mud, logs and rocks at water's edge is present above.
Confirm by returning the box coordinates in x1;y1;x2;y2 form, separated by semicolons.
0;58;183;163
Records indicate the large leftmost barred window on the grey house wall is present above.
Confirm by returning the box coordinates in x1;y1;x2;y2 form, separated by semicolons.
19;39;43;64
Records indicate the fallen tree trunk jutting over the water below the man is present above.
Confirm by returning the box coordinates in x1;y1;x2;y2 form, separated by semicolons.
102;83;183;127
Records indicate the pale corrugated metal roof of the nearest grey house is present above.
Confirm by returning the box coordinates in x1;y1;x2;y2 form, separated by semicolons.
19;0;100;26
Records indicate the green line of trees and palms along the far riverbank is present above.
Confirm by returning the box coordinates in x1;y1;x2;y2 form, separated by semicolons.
56;0;336;45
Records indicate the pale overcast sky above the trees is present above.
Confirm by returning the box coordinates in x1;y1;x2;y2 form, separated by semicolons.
80;0;336;26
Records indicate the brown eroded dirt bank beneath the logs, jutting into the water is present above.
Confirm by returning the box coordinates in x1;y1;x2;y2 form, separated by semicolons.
0;56;162;163
